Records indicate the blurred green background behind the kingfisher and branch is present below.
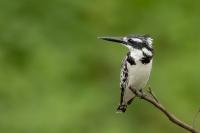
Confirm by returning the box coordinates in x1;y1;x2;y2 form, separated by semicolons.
0;0;200;133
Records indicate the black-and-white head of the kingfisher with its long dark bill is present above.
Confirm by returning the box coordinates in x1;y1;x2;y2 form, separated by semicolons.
99;35;153;52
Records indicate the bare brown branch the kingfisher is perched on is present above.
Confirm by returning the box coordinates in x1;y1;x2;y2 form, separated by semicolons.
130;88;200;133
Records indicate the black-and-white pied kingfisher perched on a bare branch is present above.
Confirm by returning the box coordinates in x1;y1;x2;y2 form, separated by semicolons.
98;34;154;113
